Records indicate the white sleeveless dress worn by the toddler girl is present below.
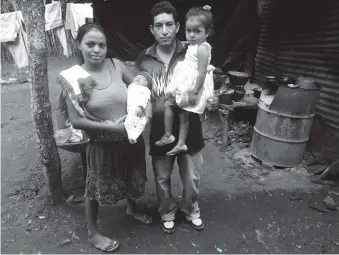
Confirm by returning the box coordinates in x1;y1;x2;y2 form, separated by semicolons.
166;42;214;114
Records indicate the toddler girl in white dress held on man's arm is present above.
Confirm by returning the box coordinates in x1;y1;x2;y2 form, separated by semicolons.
156;5;214;156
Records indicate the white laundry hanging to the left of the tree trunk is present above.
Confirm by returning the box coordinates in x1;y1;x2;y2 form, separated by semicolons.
0;12;28;68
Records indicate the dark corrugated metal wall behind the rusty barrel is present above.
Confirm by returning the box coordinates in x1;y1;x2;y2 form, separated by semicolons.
254;0;339;130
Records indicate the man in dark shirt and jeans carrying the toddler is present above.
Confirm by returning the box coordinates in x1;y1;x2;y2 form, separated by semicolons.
136;1;205;234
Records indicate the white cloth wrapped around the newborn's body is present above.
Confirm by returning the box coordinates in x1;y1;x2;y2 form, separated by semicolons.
124;83;151;143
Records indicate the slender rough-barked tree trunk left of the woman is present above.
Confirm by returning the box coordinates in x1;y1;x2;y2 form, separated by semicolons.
22;0;64;204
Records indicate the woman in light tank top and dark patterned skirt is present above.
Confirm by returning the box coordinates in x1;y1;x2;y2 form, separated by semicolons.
66;24;151;252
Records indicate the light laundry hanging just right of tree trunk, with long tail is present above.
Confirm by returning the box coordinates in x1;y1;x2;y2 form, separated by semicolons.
45;2;71;57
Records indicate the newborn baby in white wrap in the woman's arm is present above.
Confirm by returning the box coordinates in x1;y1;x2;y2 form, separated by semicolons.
125;72;152;143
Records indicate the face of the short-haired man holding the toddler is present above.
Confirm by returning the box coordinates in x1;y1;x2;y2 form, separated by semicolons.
150;13;180;46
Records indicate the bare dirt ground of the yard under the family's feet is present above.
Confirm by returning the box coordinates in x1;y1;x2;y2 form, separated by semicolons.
1;58;339;254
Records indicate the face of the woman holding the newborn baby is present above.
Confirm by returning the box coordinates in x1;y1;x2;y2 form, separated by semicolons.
79;29;107;64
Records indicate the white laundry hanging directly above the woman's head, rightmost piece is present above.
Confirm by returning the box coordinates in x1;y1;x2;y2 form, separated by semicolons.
65;3;93;39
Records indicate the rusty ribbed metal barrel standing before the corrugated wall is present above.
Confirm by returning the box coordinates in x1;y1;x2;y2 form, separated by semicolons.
251;80;320;167
